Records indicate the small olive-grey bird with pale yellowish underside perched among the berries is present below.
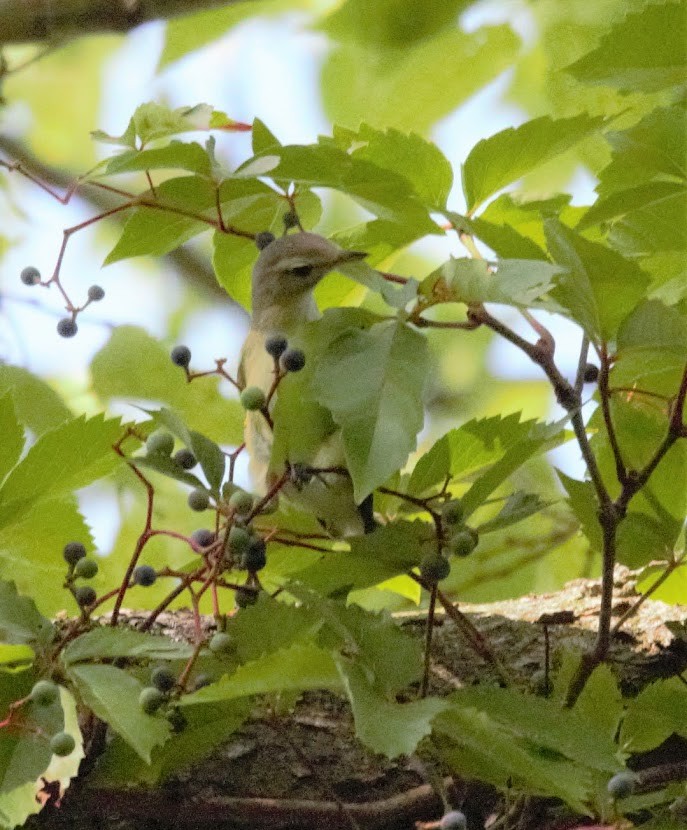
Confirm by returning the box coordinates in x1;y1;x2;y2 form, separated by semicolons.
238;231;376;538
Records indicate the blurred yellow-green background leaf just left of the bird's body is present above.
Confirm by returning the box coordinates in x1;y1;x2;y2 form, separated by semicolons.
91;326;245;445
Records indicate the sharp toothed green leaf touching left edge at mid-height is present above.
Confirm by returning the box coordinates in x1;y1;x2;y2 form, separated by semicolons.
0;415;122;527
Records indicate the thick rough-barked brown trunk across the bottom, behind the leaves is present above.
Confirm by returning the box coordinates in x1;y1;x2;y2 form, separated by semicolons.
25;568;687;830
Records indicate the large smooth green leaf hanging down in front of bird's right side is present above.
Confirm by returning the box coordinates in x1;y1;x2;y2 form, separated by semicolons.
312;320;428;503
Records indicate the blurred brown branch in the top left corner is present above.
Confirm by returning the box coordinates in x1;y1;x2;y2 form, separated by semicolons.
0;0;254;46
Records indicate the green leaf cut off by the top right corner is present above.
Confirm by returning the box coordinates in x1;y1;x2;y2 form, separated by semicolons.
566;2;687;93
